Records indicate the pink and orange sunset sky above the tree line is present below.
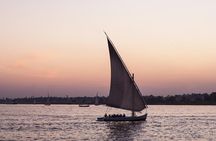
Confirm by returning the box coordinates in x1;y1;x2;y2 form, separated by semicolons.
0;0;216;98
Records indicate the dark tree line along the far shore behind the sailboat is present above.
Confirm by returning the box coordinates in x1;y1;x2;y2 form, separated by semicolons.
0;92;216;105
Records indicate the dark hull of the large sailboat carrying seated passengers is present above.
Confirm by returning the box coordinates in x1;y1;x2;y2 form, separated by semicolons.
97;113;147;121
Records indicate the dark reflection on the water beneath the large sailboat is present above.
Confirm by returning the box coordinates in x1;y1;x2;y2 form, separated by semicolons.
107;121;145;141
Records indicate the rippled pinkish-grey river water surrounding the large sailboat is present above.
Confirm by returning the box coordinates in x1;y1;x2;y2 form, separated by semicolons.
0;105;216;141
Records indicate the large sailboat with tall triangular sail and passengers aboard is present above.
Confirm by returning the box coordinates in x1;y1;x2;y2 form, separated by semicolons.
97;33;147;121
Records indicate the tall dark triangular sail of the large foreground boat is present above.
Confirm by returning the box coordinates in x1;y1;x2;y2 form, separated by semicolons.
106;33;146;111
